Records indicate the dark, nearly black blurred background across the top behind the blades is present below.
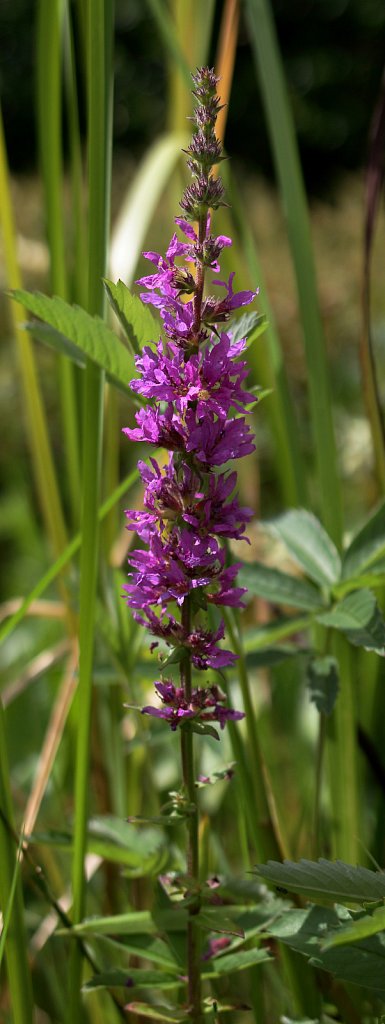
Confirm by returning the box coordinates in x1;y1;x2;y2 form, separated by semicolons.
0;0;385;186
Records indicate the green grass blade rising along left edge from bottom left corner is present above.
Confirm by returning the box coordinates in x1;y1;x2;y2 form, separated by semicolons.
0;701;34;1024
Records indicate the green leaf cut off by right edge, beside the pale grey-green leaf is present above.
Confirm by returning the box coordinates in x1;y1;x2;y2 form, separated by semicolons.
342;502;385;580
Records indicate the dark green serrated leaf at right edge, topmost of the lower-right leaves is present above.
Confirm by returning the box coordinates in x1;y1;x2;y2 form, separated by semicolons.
257;858;385;903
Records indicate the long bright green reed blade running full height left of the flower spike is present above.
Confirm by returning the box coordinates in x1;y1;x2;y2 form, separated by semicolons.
68;0;114;1024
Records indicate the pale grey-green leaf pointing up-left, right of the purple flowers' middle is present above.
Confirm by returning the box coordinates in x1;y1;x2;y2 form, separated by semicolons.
265;509;341;587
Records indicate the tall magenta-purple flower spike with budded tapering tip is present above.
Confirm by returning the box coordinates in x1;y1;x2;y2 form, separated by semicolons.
125;68;256;729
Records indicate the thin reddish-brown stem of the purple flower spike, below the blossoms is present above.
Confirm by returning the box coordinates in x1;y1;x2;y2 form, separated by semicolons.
180;597;202;1024
